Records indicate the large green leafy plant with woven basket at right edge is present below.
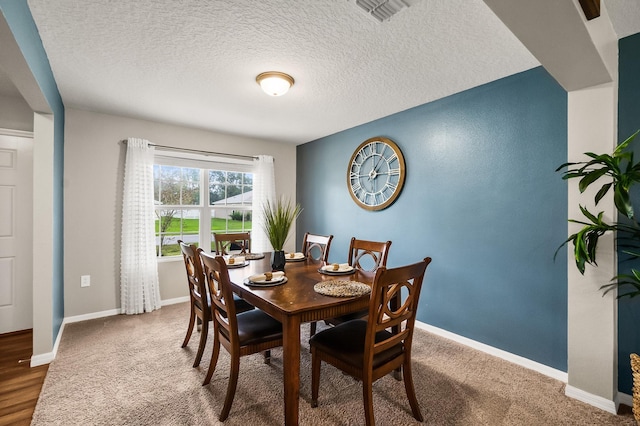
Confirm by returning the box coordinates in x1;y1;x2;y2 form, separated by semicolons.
556;130;640;424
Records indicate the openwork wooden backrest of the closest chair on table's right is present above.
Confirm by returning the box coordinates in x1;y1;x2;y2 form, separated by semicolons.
364;257;431;365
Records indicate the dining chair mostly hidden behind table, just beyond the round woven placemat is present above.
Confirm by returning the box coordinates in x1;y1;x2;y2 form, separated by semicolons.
325;237;391;325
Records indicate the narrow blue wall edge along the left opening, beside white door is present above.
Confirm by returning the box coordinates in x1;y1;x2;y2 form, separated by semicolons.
0;0;64;341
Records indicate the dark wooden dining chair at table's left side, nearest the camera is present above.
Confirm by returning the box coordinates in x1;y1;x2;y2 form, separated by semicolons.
200;249;282;421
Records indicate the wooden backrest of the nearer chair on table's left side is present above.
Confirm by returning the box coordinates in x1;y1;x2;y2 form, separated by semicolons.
198;249;239;346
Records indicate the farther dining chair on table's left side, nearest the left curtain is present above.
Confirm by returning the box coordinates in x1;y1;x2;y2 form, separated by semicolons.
178;240;255;367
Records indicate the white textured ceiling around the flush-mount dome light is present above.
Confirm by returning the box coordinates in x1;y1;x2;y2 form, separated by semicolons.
0;0;640;144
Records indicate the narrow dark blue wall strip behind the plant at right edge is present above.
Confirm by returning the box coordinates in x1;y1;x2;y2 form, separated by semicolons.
618;34;640;394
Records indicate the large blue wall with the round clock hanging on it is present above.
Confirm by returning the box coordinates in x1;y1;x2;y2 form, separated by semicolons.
297;68;567;371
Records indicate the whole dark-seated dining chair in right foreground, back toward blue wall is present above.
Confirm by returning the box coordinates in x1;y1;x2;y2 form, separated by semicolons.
309;257;431;425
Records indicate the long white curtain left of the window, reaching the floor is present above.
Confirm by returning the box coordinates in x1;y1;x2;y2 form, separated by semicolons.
120;138;160;314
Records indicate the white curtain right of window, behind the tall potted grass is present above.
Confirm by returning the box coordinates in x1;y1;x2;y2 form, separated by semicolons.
251;155;276;253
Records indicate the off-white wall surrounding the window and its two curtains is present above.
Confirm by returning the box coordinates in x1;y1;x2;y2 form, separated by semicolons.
64;108;296;317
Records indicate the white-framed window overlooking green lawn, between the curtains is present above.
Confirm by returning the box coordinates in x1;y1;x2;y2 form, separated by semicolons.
153;154;253;257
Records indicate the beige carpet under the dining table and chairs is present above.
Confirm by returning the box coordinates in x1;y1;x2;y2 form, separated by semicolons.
32;304;635;426
